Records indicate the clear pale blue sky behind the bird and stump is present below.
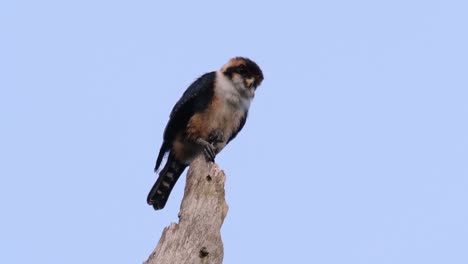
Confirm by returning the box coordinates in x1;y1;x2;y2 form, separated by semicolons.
0;1;468;264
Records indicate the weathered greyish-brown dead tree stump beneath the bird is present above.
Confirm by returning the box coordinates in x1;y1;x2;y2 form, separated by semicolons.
145;155;228;264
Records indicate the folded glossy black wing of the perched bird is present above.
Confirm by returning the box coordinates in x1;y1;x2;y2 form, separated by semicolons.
154;72;216;171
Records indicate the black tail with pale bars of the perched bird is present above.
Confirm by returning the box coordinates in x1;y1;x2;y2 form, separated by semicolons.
147;155;187;210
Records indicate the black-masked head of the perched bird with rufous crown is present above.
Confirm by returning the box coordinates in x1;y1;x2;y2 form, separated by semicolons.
221;57;263;93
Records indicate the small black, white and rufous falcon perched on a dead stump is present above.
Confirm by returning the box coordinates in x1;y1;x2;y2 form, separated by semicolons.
147;57;263;210
